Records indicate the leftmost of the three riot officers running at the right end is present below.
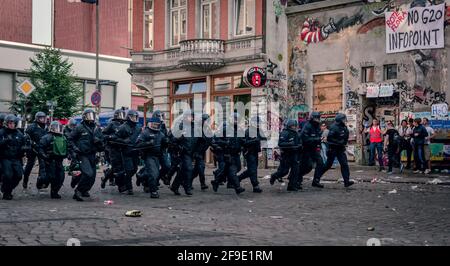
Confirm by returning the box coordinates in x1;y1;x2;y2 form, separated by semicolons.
270;119;301;192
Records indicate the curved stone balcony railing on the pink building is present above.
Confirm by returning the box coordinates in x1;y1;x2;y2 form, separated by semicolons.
178;39;225;72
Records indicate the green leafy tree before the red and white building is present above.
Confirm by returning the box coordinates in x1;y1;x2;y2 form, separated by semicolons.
11;48;83;118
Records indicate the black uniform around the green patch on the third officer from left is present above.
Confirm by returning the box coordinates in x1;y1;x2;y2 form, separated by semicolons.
39;132;67;199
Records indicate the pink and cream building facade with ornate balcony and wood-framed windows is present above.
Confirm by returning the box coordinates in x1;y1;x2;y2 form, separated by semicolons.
129;0;288;129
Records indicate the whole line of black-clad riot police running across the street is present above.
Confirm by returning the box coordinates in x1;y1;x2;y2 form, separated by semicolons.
0;108;354;201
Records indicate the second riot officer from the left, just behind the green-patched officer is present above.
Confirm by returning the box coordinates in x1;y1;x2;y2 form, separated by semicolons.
22;112;47;189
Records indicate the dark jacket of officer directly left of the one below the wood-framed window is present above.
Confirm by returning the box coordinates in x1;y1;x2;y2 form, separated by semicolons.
114;120;142;156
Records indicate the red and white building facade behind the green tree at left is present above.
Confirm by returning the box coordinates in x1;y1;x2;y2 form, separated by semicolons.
0;0;133;112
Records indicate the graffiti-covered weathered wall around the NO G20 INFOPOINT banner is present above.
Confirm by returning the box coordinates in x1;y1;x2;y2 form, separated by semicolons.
287;0;450;161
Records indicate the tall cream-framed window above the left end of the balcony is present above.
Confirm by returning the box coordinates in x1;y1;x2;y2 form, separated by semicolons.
170;0;187;46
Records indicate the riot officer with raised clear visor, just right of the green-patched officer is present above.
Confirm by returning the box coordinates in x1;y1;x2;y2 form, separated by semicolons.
69;109;104;201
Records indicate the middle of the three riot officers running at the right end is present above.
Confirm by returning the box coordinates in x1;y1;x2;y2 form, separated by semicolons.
299;112;324;188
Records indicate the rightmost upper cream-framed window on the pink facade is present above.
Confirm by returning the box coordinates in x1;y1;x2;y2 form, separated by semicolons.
234;0;256;36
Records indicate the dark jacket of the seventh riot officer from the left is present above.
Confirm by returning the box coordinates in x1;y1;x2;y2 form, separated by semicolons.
136;127;167;157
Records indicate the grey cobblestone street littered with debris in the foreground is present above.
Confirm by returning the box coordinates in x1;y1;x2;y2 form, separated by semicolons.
0;167;450;246
